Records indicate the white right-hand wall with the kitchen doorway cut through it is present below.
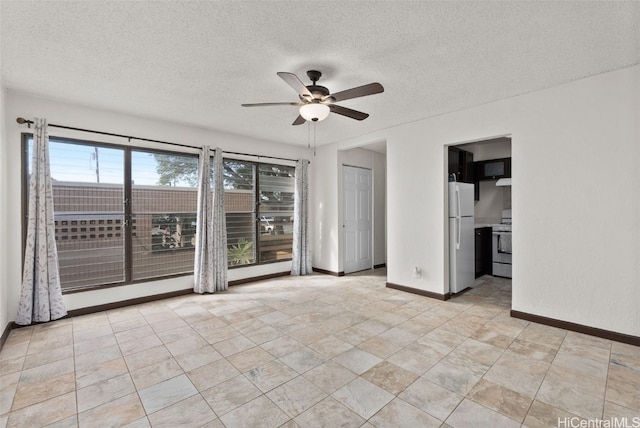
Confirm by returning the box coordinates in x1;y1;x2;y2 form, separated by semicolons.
326;66;640;336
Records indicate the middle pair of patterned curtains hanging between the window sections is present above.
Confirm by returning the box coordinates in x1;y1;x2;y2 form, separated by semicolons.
193;146;229;294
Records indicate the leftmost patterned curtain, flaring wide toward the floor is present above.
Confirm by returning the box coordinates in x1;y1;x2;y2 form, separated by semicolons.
15;118;67;325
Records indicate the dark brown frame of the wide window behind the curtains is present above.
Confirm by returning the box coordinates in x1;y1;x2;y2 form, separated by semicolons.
20;132;295;294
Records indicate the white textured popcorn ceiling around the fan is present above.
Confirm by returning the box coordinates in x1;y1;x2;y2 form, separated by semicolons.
0;0;640;145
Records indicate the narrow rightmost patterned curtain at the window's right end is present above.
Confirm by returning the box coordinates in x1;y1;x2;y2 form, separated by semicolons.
291;159;312;275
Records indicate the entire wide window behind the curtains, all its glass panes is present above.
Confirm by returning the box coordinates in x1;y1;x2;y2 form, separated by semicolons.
23;135;295;292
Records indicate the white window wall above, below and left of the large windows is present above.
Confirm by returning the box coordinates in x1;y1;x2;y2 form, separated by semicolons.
0;91;314;320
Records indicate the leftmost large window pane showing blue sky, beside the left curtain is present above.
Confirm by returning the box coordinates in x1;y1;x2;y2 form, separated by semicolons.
25;138;125;290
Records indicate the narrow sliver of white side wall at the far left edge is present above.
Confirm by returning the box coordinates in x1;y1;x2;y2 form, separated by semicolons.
0;84;7;334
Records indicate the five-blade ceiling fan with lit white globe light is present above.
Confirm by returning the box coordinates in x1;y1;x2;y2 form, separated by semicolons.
242;70;384;125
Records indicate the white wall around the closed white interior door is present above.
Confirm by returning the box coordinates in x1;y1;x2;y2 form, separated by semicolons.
338;148;387;272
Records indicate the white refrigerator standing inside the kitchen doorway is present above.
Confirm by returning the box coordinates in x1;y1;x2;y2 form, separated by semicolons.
449;181;475;294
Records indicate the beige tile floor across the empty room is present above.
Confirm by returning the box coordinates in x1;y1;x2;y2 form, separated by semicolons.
0;270;640;428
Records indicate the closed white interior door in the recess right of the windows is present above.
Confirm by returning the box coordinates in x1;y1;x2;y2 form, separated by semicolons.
342;165;373;273
